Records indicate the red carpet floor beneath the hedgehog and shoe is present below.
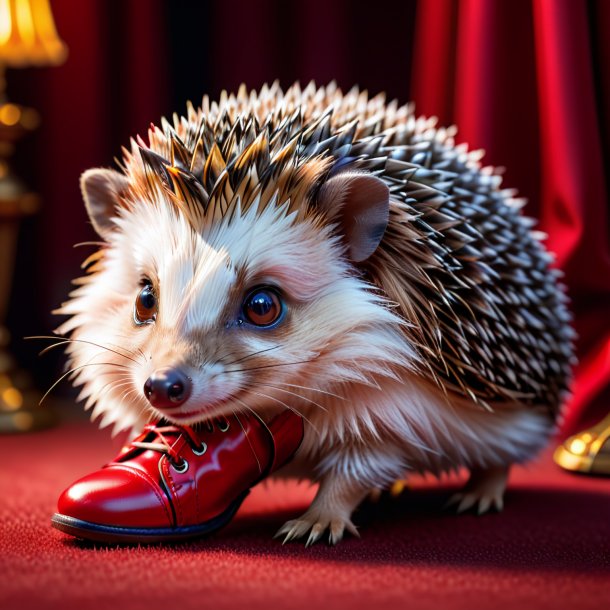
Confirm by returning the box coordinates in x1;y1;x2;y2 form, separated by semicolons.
0;416;610;610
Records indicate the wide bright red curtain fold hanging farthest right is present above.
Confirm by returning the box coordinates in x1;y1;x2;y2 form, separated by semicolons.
534;0;610;429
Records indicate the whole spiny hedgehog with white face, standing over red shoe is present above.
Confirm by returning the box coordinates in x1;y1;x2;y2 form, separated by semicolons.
57;83;574;544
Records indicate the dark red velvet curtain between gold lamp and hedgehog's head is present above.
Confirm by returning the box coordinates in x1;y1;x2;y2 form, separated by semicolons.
7;0;170;376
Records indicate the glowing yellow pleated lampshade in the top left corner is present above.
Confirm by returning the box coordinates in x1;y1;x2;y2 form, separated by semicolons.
0;0;68;68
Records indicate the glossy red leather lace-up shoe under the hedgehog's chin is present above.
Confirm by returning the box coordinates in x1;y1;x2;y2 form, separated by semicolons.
51;411;303;543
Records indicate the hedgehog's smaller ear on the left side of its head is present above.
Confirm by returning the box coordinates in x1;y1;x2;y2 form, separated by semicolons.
80;169;129;239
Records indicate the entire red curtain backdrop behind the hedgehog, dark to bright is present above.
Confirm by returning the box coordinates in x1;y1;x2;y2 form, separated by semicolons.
8;0;610;430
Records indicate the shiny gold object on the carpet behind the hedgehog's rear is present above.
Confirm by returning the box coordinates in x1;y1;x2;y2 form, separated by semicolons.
553;414;610;476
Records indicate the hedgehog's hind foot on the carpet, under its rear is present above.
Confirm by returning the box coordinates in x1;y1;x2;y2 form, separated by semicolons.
446;466;510;515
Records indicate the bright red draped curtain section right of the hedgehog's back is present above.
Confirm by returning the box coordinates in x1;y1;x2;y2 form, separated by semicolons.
412;0;610;430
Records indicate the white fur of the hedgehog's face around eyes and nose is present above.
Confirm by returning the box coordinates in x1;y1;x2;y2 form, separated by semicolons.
58;192;415;431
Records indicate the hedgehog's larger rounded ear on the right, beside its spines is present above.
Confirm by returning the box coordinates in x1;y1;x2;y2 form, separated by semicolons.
317;172;390;263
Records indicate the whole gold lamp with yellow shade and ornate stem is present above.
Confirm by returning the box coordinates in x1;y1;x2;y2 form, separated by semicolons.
0;0;67;432
